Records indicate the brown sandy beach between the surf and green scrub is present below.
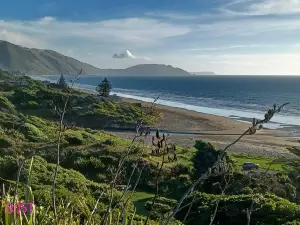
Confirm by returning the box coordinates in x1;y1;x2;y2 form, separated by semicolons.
114;98;300;157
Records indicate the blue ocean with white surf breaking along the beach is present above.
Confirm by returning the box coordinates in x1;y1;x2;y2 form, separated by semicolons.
35;75;300;135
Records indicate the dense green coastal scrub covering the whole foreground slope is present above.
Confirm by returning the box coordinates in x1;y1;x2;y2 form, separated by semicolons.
0;71;300;225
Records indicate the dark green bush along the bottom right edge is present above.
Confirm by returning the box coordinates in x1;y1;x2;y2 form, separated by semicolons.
176;193;300;225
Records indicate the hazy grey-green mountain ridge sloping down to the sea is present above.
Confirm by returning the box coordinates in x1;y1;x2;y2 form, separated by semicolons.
0;40;211;76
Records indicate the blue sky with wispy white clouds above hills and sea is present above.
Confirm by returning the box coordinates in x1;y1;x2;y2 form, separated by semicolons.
0;0;300;75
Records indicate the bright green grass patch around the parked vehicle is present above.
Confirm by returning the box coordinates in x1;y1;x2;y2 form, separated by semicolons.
230;154;287;171
